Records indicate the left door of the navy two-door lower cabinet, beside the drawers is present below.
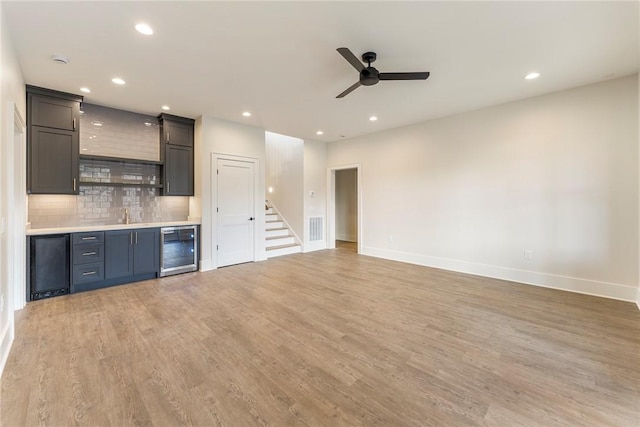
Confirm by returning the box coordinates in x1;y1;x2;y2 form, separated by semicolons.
104;230;134;279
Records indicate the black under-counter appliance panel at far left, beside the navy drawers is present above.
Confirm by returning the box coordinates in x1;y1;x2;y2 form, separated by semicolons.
29;234;71;300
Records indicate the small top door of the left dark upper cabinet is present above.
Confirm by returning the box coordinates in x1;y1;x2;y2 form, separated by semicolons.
29;94;80;131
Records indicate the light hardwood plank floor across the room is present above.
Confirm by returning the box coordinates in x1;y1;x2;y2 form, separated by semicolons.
0;247;640;427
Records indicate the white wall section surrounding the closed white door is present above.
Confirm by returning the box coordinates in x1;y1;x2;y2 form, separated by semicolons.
194;117;266;270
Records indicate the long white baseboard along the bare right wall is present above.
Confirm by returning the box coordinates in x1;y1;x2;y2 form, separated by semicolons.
361;246;640;302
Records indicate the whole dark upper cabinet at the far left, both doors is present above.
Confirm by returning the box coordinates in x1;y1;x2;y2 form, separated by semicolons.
27;85;83;194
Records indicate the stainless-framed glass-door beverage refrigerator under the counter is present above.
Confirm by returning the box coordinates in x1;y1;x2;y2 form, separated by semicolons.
160;225;198;277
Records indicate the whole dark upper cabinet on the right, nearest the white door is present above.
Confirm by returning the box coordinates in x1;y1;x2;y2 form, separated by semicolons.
158;114;194;196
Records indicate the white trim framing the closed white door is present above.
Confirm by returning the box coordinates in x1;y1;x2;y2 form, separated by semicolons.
210;153;267;271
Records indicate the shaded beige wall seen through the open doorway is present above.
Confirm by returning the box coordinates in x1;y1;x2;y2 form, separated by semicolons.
335;169;358;242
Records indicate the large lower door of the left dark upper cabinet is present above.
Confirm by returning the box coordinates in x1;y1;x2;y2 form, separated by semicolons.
27;126;79;194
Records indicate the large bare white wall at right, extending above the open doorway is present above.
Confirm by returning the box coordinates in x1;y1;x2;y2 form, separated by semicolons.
327;75;639;301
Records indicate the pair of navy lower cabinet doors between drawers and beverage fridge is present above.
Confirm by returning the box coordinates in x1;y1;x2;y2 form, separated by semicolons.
104;228;160;280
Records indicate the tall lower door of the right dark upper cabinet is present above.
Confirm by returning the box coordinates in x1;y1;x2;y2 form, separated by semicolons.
164;145;193;196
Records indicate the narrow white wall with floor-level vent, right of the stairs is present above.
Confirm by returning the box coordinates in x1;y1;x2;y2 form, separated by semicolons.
303;140;327;252
